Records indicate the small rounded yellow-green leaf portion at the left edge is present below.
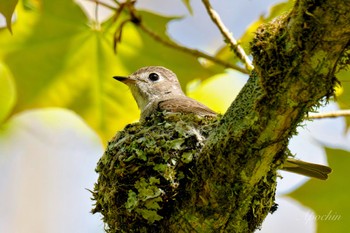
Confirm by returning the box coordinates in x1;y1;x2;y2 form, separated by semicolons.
0;63;16;124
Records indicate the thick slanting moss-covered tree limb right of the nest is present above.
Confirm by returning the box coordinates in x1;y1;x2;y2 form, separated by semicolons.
170;0;350;232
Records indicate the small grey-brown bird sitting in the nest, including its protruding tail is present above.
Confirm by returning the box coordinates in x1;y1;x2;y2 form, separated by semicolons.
113;66;332;180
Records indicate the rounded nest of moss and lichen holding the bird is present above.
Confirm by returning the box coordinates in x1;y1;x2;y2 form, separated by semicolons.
92;112;219;232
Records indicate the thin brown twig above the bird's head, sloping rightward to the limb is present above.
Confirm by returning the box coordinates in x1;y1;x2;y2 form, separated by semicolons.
137;23;249;74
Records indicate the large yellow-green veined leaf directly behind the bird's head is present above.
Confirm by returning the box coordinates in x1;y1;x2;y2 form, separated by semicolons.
0;0;212;142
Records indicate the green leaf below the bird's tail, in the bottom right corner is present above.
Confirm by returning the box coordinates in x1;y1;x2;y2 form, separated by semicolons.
290;148;350;233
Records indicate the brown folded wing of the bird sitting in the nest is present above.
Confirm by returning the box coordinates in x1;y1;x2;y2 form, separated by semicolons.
158;97;217;116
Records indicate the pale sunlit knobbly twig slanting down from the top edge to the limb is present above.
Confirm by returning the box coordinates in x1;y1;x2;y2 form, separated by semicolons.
202;0;254;71
